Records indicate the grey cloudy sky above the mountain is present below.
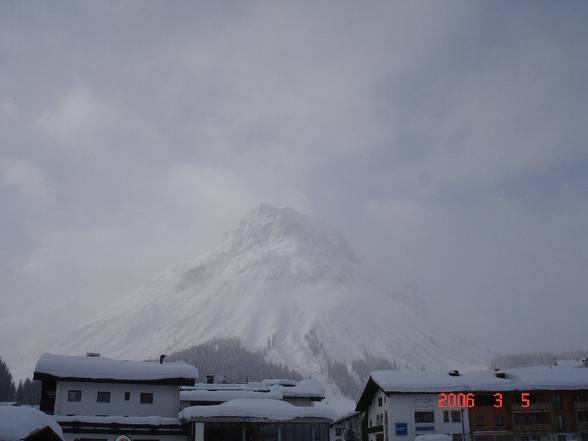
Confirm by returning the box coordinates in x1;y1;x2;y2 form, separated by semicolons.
0;0;588;368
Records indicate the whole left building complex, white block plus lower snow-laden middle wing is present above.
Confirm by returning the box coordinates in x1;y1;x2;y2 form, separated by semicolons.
34;354;335;441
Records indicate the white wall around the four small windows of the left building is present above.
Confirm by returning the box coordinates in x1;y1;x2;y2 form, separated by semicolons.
55;381;180;418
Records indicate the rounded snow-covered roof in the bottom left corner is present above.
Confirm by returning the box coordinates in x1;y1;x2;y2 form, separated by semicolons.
0;406;63;441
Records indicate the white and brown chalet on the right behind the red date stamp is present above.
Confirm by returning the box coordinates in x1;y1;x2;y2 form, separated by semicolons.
356;364;588;441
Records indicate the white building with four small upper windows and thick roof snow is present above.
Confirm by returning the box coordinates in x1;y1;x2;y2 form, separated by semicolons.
34;354;198;441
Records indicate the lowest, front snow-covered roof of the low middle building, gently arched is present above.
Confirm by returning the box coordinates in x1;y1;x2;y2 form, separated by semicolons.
180;399;336;422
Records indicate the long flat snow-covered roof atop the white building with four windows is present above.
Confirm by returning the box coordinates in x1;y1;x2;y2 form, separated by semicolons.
35;354;198;384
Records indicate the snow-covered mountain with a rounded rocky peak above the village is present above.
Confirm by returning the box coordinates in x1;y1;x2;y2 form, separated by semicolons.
56;205;487;392
